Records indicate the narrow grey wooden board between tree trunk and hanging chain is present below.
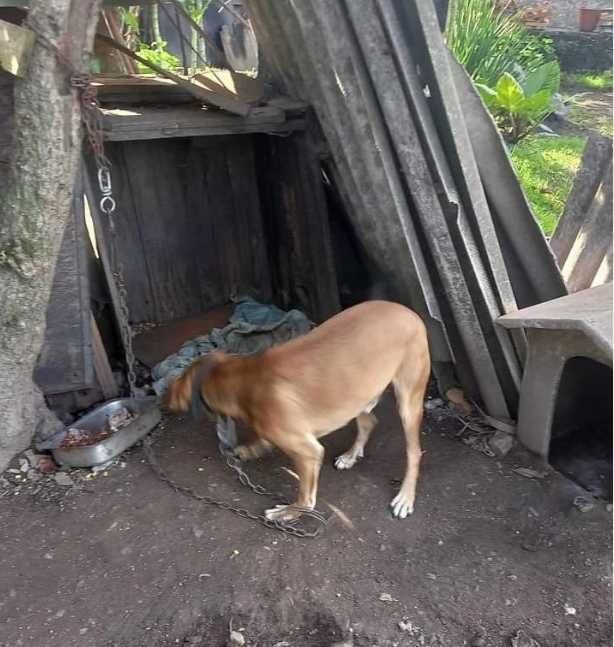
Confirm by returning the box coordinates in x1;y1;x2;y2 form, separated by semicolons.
34;170;96;395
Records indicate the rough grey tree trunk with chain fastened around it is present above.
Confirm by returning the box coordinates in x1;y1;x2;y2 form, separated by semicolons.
0;0;100;473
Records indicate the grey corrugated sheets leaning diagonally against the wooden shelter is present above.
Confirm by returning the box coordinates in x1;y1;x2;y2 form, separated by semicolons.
246;0;565;417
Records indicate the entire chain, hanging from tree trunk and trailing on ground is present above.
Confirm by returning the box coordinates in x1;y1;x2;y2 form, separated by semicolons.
24;20;328;538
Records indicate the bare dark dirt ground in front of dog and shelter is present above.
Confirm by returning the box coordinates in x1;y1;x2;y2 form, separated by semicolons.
0;399;612;647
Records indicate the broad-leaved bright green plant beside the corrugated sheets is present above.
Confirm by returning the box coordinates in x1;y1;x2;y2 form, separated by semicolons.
476;61;561;143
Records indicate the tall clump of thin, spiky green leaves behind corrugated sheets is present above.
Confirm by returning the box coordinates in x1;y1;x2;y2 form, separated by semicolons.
446;0;554;87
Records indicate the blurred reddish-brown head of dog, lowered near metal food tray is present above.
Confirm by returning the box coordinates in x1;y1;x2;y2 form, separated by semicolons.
162;353;224;418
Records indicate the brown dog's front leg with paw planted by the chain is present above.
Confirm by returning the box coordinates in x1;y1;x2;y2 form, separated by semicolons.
265;435;324;521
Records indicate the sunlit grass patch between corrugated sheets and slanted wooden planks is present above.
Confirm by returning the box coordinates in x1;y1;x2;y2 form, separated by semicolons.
512;135;586;236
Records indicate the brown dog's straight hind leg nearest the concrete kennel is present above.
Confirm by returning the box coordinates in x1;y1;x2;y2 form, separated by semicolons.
390;352;430;519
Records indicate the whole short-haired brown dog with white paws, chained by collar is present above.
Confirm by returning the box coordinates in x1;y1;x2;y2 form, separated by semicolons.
165;301;430;521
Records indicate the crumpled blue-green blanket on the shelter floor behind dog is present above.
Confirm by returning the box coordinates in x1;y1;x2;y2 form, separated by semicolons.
152;297;313;397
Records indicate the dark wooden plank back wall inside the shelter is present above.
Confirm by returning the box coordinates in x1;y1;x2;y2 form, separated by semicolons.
90;137;270;323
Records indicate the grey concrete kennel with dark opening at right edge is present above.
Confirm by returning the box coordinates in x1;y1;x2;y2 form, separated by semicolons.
497;283;612;458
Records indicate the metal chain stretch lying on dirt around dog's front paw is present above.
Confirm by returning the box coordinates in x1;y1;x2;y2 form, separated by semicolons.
143;434;328;539
